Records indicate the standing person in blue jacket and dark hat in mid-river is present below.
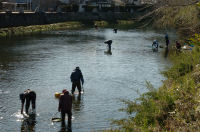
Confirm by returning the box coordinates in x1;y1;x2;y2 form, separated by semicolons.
70;67;84;94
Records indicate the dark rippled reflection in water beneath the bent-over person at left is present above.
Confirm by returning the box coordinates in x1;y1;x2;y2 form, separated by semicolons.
21;113;36;132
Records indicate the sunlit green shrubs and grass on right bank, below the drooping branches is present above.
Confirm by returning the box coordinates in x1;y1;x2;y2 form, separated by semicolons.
104;34;200;132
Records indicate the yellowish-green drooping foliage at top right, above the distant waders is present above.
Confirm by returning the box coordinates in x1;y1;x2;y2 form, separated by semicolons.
153;5;200;37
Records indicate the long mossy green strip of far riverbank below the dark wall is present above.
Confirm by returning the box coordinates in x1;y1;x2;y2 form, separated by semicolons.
0;20;134;38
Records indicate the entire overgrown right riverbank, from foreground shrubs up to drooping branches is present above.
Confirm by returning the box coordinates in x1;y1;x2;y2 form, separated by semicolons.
105;2;200;132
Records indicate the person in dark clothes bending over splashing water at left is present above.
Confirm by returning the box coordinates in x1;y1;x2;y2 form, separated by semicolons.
19;89;36;114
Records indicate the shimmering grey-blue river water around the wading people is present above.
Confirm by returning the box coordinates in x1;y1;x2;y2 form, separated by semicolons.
0;29;173;132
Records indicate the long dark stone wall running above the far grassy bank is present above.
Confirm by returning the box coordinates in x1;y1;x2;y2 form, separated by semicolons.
0;12;133;28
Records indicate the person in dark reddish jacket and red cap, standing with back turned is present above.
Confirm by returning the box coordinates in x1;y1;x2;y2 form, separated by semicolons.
58;89;72;129
